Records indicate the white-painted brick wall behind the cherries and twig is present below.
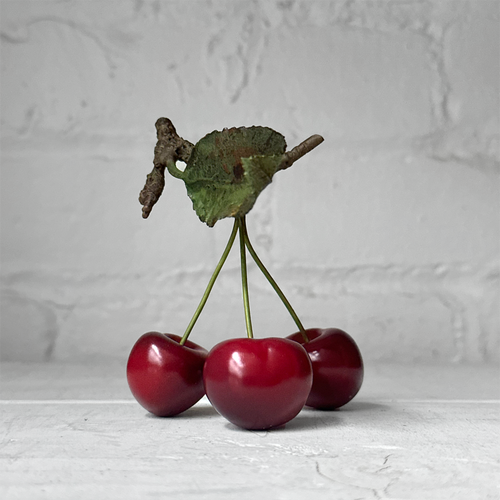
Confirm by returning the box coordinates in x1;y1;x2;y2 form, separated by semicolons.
0;0;500;362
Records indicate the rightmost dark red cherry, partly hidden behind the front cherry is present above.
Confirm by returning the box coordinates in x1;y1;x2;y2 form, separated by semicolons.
287;328;364;410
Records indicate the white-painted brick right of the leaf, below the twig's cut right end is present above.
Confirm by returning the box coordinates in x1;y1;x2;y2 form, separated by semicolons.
271;150;500;267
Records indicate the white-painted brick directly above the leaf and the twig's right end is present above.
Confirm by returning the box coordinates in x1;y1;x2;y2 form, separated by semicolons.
249;25;433;141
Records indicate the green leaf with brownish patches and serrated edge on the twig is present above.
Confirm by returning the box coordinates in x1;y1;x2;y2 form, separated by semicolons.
178;127;286;226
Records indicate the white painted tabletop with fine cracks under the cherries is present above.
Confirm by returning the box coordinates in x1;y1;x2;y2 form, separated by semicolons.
0;364;500;500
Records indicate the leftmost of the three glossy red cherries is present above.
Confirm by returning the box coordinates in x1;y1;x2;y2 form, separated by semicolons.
127;332;208;417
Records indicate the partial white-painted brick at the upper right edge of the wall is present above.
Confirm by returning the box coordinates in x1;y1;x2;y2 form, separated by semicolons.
433;9;500;162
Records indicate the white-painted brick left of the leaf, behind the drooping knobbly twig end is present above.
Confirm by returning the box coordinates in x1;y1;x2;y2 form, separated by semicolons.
0;141;218;274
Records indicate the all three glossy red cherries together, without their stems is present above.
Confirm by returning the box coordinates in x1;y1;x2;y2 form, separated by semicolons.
127;328;363;429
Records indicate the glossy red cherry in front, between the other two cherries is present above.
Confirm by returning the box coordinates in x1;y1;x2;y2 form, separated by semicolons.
203;338;312;429
